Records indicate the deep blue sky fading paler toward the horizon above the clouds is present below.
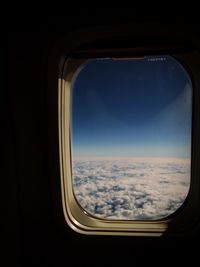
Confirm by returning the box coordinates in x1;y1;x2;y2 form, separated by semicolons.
71;56;192;158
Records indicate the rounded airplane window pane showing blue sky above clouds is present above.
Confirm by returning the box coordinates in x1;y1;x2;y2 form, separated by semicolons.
71;55;192;220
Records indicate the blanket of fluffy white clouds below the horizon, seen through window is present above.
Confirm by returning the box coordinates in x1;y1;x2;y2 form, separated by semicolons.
73;158;190;220
